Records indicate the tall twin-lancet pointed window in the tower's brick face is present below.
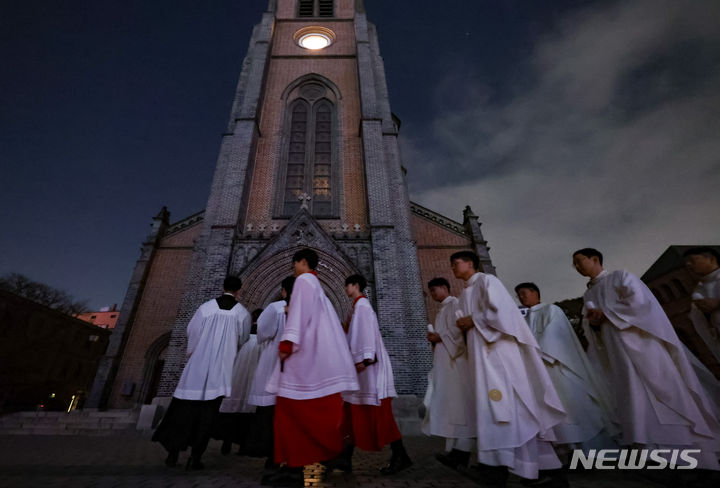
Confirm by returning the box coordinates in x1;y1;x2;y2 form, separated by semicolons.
278;99;338;218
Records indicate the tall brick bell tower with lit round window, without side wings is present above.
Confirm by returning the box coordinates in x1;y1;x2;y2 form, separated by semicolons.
158;0;430;397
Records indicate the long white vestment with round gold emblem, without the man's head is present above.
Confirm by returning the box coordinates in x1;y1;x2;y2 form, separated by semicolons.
459;273;565;479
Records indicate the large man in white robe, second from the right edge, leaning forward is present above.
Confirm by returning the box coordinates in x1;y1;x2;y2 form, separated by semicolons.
573;248;720;470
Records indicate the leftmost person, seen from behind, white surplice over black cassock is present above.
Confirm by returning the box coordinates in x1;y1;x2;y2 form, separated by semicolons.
153;276;250;469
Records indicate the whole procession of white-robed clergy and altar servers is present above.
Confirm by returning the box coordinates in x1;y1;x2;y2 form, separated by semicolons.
153;248;720;486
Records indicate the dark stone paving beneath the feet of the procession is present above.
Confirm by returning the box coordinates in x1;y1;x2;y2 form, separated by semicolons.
0;435;708;488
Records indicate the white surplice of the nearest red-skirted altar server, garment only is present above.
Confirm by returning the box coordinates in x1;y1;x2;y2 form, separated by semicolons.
267;273;359;400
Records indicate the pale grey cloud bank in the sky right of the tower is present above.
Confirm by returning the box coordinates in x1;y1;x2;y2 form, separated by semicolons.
404;1;720;300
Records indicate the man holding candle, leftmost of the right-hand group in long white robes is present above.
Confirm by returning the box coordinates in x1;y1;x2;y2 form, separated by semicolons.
421;278;477;469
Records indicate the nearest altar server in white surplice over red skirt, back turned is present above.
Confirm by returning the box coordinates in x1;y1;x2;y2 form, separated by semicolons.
267;248;359;486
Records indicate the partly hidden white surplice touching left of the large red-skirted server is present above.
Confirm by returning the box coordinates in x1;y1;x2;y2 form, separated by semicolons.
248;300;287;407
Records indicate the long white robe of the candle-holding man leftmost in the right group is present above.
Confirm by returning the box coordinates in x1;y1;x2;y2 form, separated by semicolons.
422;296;477;439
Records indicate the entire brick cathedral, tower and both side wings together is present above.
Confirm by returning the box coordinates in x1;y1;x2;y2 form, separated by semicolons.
87;0;494;408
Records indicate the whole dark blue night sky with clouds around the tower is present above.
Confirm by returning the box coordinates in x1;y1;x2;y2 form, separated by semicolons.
0;0;720;308
